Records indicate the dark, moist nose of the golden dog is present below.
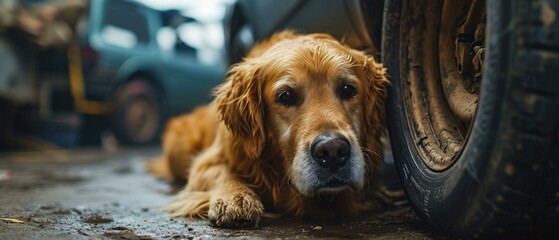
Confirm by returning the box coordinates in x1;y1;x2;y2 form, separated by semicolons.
311;134;351;171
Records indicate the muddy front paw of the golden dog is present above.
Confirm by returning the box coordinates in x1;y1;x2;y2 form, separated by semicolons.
208;192;264;228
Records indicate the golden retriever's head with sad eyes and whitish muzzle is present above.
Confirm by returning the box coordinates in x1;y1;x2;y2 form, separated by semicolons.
217;34;389;196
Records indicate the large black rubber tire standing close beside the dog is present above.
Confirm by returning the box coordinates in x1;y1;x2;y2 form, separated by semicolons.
382;0;559;238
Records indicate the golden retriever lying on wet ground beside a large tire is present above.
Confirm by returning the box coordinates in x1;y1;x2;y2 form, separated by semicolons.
150;31;389;227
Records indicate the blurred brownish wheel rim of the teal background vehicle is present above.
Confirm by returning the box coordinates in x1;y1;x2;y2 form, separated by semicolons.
125;97;159;143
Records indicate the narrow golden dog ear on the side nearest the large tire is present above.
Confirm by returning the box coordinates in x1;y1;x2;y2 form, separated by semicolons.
351;50;390;163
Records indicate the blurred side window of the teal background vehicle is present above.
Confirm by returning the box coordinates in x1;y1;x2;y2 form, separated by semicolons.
101;1;150;48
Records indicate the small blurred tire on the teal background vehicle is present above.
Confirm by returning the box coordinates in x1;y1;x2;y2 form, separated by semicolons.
111;79;165;145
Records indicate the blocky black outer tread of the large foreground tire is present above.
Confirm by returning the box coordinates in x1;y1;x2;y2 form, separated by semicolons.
481;1;559;236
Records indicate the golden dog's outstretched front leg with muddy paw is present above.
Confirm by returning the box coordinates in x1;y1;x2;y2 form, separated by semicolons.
175;145;264;228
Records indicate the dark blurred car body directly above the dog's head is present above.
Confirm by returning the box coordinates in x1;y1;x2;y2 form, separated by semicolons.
224;0;383;63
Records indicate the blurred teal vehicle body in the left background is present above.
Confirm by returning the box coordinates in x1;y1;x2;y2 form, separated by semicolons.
80;0;224;114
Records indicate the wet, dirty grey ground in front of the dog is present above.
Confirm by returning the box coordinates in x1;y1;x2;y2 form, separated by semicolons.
0;148;445;239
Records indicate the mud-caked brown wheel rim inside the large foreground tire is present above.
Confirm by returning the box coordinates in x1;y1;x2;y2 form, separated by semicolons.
400;0;485;171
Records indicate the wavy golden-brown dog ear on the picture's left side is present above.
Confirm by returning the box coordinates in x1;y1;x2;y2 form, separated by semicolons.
214;59;265;159
